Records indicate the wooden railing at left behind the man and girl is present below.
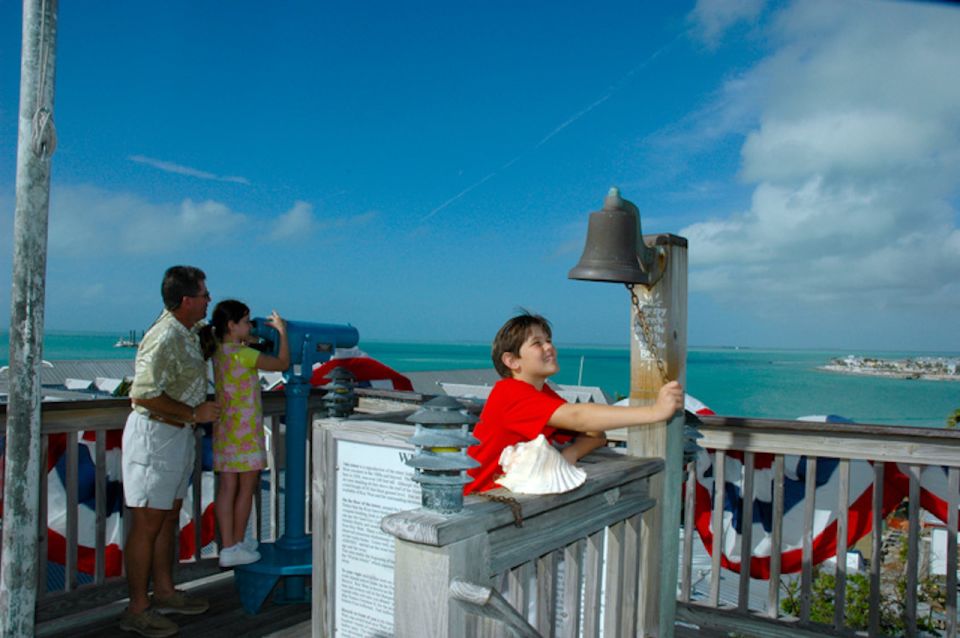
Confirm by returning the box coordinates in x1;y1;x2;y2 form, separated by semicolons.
0;391;323;623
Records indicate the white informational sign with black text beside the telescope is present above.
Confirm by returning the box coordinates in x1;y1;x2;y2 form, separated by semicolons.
333;438;420;638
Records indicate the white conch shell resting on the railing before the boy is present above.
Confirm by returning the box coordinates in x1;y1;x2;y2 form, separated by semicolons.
496;434;587;494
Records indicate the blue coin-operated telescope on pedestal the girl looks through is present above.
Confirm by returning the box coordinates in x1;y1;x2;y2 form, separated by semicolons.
233;317;360;614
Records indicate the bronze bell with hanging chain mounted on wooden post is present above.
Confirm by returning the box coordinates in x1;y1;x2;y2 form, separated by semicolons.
567;188;663;286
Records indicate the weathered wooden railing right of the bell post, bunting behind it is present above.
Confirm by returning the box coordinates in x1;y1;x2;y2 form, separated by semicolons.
677;417;960;636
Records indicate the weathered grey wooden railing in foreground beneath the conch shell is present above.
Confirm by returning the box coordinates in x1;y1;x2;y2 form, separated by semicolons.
382;450;663;638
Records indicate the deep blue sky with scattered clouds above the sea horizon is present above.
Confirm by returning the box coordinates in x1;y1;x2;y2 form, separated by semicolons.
0;0;960;351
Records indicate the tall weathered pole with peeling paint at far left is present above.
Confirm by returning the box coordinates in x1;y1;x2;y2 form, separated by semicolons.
0;0;57;636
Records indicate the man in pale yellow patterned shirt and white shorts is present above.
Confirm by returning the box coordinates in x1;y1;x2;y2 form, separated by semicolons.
120;266;219;638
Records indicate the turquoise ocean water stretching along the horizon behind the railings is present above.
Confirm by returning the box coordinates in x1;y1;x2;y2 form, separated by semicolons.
0;331;960;427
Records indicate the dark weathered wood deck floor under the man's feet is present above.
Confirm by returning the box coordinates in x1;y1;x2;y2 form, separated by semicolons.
36;572;310;638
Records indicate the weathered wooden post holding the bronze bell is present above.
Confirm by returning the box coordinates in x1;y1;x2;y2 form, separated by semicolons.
627;235;687;638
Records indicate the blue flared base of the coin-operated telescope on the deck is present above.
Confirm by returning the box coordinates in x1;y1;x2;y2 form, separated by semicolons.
233;537;313;614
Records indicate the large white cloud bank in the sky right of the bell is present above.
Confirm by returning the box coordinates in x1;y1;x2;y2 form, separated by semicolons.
680;0;960;318
